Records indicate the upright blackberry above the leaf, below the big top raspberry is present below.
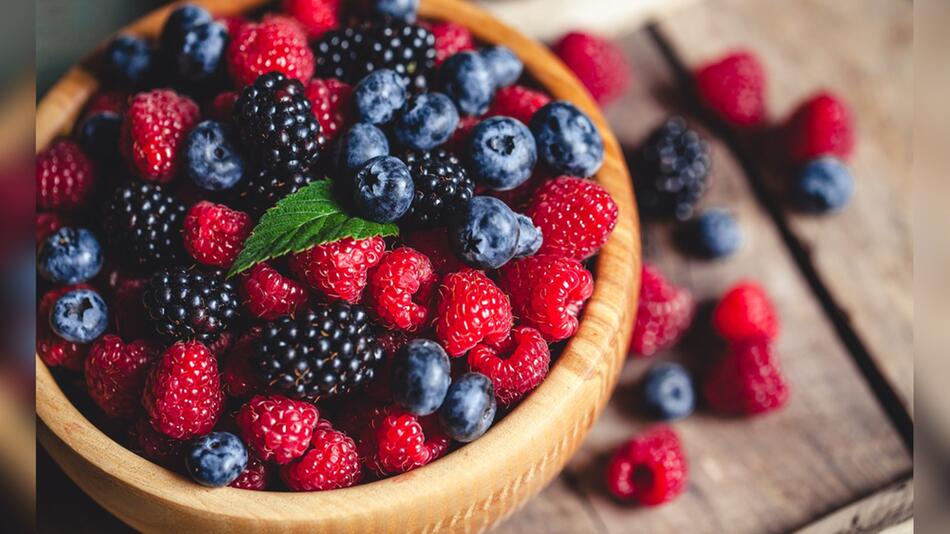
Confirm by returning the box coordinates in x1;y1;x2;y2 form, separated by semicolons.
234;72;326;172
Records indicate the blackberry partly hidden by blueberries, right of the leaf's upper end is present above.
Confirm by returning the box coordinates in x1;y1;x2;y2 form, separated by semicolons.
403;149;475;228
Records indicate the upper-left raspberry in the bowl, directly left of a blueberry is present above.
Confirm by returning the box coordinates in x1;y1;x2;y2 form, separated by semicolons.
122;89;200;183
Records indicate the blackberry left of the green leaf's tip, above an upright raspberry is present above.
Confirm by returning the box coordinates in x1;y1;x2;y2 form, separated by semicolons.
142;267;238;343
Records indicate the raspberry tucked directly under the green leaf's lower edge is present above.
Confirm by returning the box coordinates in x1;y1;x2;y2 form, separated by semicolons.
290;237;386;303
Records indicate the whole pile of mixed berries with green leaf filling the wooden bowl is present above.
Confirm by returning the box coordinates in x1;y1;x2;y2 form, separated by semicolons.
36;0;620;491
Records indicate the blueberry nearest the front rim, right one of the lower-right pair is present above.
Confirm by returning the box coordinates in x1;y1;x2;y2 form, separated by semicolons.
439;373;497;443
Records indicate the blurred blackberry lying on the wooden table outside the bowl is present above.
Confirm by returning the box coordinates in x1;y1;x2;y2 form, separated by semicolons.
634;117;712;220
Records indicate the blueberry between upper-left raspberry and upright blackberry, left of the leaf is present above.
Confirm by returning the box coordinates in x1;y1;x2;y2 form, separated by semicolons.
184;120;244;191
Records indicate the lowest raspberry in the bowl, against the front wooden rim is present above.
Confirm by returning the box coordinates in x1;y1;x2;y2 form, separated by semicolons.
280;420;363;491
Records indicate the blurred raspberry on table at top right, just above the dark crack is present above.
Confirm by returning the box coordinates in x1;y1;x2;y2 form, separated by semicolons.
694;50;766;126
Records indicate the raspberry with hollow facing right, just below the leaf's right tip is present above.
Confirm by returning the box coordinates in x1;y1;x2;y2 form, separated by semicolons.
368;247;437;332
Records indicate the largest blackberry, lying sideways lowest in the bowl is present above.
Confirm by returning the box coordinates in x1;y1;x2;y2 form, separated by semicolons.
252;301;383;402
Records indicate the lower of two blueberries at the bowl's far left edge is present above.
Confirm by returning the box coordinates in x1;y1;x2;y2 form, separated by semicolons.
49;289;109;343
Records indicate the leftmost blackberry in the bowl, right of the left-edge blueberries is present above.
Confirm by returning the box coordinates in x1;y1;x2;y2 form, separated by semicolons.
105;183;186;269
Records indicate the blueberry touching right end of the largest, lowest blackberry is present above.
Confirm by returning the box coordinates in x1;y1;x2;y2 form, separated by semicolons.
390;339;452;415
